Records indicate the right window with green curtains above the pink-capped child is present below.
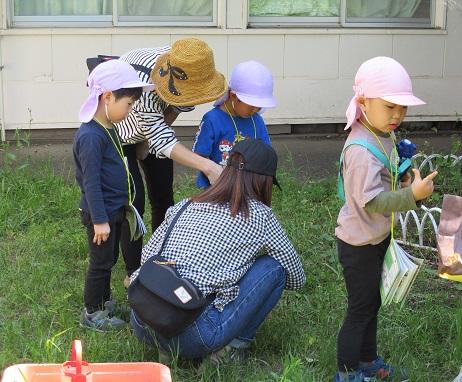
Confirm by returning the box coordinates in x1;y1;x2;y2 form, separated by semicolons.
249;0;435;28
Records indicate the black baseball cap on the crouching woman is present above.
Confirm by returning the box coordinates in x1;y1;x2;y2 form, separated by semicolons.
228;138;281;189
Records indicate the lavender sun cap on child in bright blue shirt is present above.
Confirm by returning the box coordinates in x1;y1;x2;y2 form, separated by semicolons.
214;60;276;109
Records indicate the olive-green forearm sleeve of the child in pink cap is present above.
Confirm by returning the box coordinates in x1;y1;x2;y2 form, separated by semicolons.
365;187;417;214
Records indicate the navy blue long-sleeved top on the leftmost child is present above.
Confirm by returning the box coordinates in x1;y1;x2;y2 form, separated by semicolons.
73;120;128;224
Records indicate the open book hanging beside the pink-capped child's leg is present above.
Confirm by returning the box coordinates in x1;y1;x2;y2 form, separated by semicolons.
380;239;423;305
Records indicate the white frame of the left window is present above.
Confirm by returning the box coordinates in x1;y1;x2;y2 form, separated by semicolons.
6;0;218;28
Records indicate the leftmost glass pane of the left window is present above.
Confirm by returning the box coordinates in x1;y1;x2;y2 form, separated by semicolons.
14;0;112;16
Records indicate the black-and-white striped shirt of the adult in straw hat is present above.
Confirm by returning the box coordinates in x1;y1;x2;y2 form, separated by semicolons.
116;46;194;158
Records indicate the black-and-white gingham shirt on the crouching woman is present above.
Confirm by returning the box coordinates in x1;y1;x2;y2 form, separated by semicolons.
131;200;305;311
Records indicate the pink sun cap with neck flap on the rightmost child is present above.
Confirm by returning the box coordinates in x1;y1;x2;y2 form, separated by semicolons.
345;56;425;130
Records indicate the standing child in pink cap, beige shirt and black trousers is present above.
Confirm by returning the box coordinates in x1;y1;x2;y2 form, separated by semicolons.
334;57;436;382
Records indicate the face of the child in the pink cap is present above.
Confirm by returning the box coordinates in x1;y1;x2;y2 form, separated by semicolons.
358;98;407;133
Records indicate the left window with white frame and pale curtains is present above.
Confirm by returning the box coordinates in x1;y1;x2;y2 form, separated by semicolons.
11;0;217;26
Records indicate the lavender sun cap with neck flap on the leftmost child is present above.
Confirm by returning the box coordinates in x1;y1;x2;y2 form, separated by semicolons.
79;60;154;122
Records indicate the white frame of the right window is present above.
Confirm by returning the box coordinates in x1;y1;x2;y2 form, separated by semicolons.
249;0;436;29
